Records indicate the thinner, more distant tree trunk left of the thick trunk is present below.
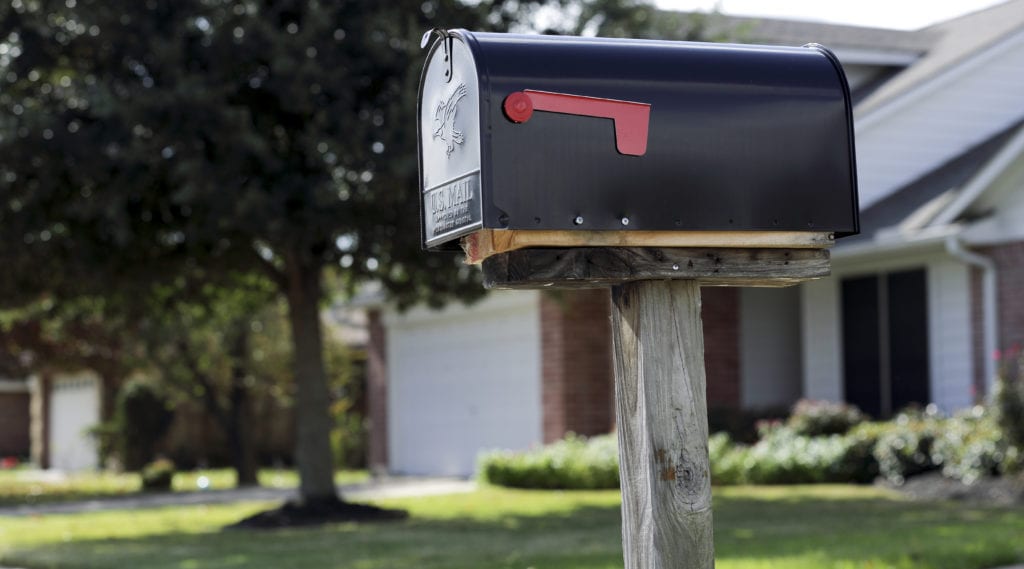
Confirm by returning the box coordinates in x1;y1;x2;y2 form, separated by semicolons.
225;318;259;487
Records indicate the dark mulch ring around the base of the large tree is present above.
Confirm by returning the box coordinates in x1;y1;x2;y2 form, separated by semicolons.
224;500;409;529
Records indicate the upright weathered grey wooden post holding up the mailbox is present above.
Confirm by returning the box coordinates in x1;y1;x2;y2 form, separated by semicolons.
611;280;715;569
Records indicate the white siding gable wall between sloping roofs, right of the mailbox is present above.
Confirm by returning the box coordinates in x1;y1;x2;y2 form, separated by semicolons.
856;33;1024;208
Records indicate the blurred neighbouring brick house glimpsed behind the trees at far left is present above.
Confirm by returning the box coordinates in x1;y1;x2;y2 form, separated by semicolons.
0;306;367;472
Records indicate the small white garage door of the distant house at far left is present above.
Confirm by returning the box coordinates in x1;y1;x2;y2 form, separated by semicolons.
49;374;99;471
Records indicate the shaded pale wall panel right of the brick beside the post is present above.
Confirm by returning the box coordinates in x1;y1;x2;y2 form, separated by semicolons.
739;287;803;408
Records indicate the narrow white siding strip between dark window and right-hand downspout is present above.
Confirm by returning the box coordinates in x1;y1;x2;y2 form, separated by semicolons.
927;259;974;412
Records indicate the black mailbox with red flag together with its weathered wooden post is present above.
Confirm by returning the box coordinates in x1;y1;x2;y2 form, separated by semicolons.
419;31;858;569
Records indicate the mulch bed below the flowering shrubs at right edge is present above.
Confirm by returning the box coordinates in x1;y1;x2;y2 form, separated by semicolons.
884;472;1024;506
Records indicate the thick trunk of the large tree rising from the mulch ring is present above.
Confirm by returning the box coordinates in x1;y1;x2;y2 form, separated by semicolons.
286;253;338;505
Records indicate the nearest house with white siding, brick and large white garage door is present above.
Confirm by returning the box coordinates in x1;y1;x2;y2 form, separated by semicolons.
368;0;1024;476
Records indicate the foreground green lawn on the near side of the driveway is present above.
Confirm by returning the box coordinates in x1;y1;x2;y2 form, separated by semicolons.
0;486;1024;569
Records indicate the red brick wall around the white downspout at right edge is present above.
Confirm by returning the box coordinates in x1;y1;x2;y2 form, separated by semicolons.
971;242;1024;394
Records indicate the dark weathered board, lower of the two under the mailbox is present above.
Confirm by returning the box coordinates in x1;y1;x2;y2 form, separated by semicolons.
481;247;830;289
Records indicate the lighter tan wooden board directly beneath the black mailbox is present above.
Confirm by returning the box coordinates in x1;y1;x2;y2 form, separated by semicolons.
462;229;836;265
